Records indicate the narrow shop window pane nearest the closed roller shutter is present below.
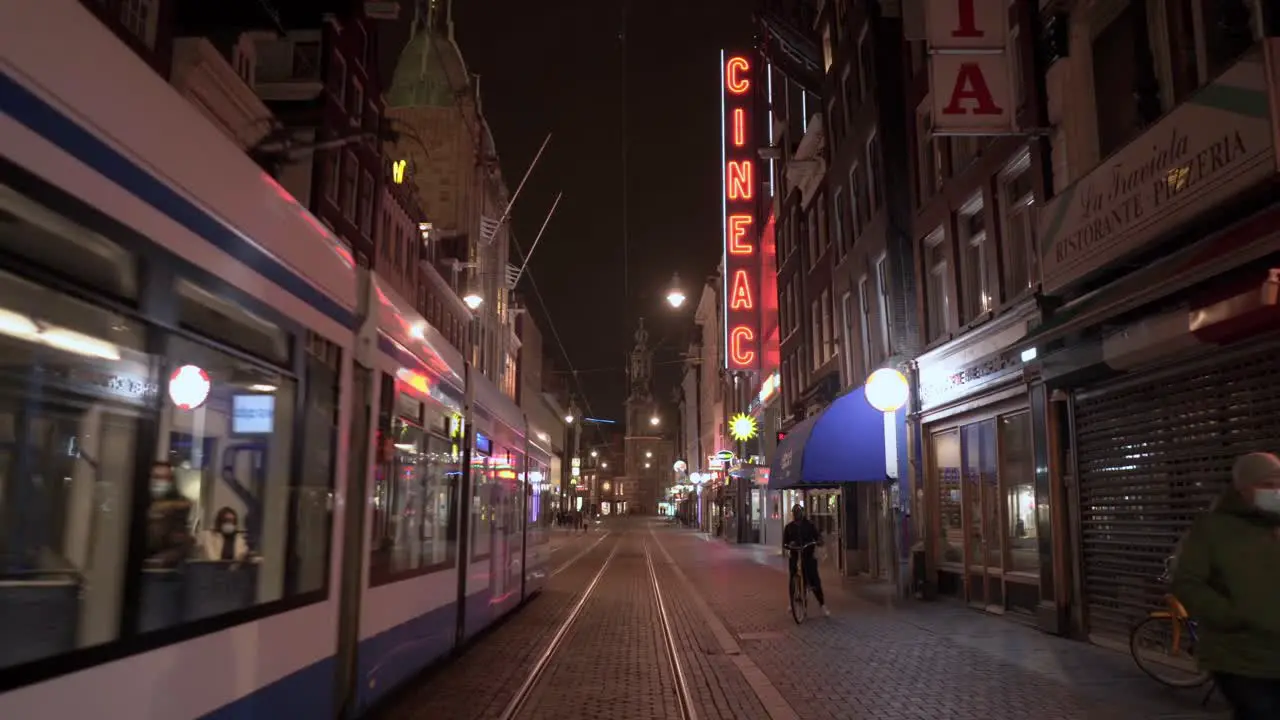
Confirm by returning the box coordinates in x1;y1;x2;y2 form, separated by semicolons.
1000;413;1039;580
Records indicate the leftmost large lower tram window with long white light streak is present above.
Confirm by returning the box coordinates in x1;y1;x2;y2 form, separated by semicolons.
0;267;151;667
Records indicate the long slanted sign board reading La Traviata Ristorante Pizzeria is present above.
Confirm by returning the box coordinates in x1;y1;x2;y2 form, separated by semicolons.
1037;53;1276;293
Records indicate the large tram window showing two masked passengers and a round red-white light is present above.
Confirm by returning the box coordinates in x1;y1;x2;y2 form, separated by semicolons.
138;337;302;632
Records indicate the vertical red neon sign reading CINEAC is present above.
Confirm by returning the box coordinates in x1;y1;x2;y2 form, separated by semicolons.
721;51;760;370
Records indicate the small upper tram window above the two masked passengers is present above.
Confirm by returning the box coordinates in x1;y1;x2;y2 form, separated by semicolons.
178;281;289;365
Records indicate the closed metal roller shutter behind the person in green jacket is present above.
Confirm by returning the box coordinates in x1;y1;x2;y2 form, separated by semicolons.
1075;340;1280;637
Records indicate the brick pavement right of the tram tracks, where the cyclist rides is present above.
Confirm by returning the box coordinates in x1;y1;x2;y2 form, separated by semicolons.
657;520;1222;720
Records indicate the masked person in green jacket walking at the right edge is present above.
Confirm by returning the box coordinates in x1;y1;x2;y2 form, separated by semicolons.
1171;452;1280;720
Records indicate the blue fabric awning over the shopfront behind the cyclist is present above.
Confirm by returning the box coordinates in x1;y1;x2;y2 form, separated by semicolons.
769;387;906;489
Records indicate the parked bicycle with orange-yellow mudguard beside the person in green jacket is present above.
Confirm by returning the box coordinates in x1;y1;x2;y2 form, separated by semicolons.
1129;557;1213;703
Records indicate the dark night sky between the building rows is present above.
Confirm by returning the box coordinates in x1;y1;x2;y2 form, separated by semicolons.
453;0;751;420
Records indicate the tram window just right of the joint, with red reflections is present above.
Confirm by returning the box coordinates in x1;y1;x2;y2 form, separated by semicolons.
369;373;458;585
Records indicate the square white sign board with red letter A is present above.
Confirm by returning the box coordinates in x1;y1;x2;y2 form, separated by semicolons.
929;53;1018;135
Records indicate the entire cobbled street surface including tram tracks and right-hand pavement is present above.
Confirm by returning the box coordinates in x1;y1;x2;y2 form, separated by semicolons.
373;520;1224;720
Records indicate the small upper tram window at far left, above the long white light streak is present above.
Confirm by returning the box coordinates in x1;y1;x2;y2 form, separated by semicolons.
0;184;138;299
